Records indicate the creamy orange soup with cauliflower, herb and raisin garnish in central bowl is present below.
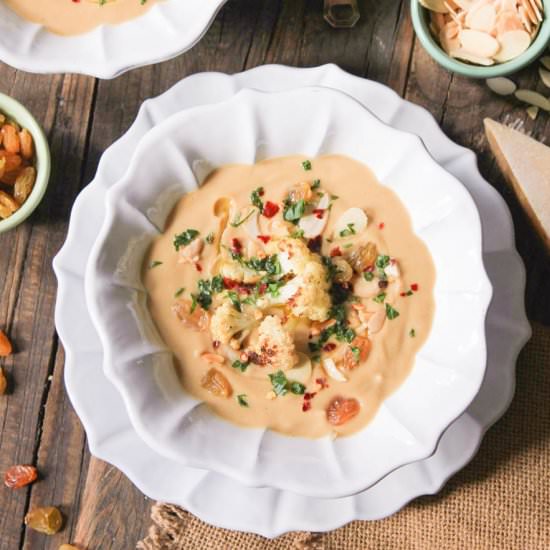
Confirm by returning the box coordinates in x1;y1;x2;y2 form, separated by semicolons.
143;155;435;438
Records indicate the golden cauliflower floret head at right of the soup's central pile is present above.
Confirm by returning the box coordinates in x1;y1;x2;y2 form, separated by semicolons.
288;262;331;321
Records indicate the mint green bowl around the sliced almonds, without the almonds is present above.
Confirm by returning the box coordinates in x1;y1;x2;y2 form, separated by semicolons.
411;0;550;78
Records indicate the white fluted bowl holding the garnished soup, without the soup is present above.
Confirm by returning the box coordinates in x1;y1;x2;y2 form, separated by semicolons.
86;87;491;498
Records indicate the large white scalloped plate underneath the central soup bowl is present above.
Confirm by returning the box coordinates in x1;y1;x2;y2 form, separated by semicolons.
54;65;530;537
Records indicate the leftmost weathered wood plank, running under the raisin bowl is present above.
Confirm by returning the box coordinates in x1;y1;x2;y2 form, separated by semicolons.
0;71;93;548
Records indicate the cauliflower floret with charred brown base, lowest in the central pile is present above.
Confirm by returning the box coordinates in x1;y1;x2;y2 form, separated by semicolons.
249;315;298;370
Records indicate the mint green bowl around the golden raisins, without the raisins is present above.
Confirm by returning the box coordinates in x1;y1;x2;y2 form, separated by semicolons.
0;93;51;233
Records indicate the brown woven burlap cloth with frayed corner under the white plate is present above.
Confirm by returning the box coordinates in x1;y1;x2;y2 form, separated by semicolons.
138;326;550;550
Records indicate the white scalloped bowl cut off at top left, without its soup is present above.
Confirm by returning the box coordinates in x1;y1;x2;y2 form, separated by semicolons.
0;0;227;78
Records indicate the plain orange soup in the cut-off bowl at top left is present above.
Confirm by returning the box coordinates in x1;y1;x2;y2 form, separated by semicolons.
4;0;159;36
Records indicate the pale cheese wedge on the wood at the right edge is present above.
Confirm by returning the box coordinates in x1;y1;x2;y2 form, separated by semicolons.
484;118;550;249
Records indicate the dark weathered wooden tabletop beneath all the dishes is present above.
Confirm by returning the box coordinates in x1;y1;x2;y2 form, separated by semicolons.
0;0;550;550
